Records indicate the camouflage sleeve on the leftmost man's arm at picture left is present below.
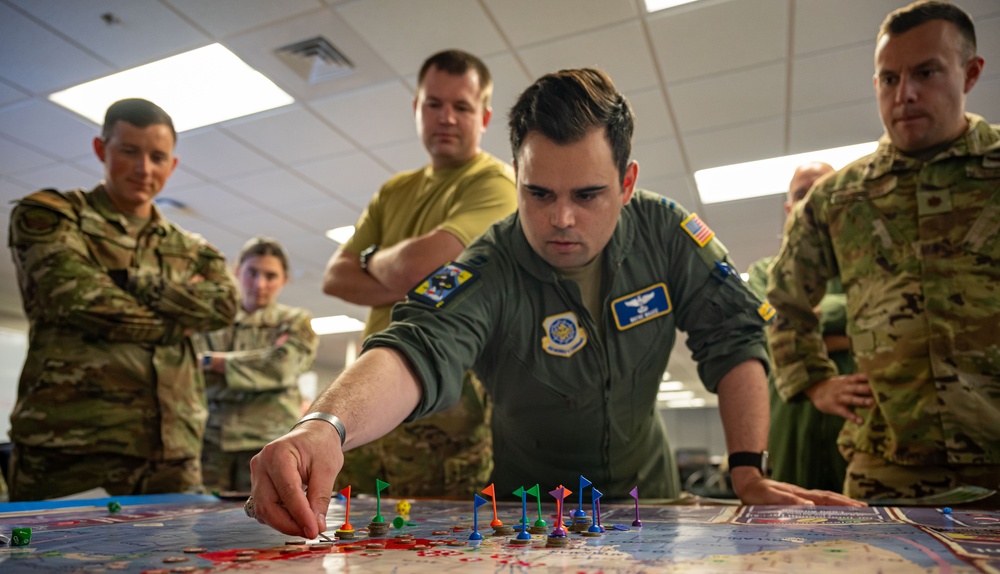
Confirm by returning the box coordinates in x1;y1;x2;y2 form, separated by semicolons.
10;204;180;343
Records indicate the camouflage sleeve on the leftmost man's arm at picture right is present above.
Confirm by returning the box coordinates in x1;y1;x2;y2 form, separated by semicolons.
129;244;238;332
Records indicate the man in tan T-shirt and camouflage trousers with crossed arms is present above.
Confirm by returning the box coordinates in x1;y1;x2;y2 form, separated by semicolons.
323;50;517;496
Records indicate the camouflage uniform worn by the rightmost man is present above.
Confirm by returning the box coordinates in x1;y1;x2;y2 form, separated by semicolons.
768;114;1000;504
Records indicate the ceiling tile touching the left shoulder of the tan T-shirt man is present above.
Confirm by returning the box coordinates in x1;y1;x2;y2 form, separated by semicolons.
295;153;392;212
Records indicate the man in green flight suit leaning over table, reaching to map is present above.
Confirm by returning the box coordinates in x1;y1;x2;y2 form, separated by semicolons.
247;69;853;537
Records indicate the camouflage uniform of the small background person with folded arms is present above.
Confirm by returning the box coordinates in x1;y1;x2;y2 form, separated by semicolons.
194;303;319;491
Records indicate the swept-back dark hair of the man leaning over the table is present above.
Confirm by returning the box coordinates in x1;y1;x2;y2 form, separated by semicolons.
508;68;635;181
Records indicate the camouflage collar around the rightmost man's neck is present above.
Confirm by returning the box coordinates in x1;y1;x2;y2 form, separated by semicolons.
864;113;1000;180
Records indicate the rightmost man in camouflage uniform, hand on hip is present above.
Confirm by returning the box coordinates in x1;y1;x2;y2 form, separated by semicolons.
768;2;1000;506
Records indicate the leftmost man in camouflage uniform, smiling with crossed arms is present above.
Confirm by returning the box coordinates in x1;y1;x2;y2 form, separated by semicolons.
10;99;236;500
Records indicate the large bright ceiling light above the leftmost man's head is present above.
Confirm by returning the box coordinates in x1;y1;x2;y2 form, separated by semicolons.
49;44;295;132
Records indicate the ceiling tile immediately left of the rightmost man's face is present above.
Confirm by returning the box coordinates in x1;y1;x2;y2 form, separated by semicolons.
791;46;875;112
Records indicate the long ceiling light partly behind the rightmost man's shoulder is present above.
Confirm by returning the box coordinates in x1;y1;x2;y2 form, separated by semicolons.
694;142;878;204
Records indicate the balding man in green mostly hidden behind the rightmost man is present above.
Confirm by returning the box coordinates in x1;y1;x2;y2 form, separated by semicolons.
747;162;855;491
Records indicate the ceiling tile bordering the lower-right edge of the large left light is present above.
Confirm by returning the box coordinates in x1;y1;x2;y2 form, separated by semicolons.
221;105;355;163
